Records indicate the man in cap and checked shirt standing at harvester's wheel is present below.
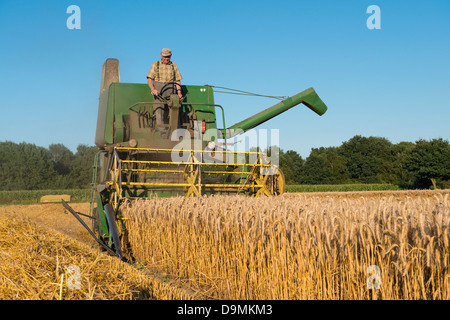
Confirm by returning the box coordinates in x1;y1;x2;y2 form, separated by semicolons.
147;48;183;130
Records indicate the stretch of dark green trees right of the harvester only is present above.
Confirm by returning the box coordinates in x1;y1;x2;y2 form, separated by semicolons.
279;135;450;189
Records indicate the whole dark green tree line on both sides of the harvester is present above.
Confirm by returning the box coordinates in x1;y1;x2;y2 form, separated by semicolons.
0;135;450;190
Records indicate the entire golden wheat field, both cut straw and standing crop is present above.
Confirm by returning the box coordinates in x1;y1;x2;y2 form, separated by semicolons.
0;190;450;300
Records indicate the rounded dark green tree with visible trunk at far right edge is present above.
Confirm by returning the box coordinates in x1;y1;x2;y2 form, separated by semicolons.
406;138;450;189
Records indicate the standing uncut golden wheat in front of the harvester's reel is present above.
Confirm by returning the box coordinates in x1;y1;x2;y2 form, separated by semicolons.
122;190;450;300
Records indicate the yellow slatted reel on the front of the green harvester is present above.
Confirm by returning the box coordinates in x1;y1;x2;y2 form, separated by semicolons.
106;147;277;209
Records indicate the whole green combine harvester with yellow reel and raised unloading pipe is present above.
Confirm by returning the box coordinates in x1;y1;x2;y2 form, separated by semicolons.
63;59;327;256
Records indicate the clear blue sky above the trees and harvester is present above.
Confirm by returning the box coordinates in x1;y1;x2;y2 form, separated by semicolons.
0;0;450;158
